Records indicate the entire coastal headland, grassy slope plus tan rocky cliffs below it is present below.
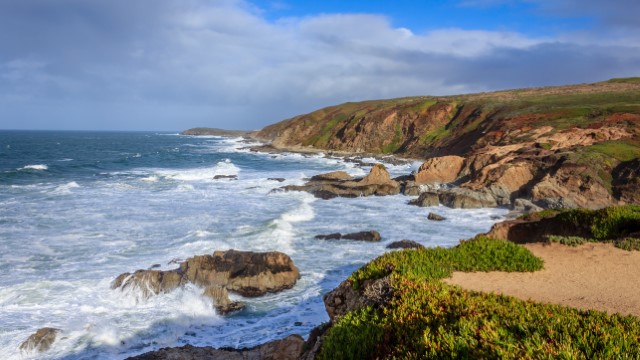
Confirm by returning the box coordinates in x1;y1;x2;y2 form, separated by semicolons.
256;78;640;208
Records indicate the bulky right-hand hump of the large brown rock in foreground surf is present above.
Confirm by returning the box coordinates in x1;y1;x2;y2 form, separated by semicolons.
180;250;300;297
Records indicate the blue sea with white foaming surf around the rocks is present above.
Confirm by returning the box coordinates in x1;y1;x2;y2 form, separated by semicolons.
0;131;506;359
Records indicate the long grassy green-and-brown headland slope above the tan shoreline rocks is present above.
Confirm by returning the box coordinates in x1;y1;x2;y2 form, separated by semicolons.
258;78;640;158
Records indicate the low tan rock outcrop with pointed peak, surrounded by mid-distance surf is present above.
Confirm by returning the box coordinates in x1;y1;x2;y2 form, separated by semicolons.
283;164;400;199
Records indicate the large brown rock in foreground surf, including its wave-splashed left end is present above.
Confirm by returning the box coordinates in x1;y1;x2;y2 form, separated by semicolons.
112;250;300;305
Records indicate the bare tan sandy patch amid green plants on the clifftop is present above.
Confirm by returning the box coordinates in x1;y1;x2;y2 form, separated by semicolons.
445;243;640;317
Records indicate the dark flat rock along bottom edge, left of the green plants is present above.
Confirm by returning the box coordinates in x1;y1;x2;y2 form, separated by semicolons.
128;335;304;360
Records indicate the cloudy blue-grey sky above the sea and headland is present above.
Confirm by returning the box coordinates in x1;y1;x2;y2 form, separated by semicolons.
0;0;640;131
